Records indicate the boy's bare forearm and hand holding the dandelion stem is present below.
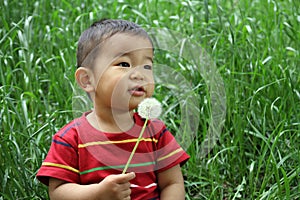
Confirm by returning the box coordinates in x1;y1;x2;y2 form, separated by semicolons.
49;173;135;200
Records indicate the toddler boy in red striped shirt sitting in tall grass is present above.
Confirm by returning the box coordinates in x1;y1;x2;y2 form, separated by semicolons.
37;20;189;200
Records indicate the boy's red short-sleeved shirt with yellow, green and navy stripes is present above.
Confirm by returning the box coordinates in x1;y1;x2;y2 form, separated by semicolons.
37;113;189;200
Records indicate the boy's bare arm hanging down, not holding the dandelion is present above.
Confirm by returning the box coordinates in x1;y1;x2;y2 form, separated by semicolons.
158;164;185;200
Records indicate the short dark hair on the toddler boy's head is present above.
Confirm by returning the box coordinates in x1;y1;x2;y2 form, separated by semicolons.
77;19;152;67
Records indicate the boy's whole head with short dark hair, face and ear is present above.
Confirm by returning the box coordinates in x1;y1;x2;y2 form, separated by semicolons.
75;20;154;110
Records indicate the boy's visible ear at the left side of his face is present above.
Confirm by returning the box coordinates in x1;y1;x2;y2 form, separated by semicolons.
75;67;95;93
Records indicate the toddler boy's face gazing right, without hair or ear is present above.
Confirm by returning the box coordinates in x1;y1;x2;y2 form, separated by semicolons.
93;33;154;111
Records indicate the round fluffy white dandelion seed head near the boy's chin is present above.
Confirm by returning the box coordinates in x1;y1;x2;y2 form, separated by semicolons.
138;98;162;119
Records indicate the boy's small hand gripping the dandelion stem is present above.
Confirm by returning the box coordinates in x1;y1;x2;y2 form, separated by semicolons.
99;172;135;200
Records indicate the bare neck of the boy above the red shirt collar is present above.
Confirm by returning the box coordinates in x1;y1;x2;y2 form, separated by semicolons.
87;109;134;133
